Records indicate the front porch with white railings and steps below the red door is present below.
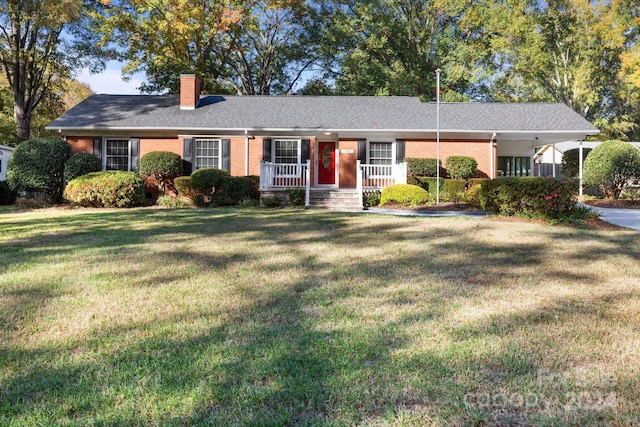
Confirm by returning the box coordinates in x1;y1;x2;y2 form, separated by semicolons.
260;160;407;209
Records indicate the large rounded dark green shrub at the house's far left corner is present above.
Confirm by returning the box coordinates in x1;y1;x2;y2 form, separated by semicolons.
7;138;71;202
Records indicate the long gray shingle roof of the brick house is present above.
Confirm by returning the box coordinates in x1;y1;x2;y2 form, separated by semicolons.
48;95;597;134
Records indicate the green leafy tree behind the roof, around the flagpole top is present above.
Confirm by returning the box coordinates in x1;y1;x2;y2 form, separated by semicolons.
310;0;500;100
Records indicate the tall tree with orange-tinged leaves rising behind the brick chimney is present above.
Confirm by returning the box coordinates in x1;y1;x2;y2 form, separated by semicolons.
102;0;322;95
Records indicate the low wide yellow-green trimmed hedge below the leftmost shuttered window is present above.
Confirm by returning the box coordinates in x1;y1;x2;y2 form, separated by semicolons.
64;171;145;208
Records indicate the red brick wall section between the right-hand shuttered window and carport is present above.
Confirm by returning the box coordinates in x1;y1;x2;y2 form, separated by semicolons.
405;140;495;178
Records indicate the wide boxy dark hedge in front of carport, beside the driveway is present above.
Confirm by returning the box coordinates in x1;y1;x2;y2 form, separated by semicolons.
479;177;578;219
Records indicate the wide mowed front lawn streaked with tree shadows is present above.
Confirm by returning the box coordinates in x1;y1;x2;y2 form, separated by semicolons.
0;208;640;426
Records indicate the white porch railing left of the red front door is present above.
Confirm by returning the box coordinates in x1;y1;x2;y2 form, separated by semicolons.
260;160;311;206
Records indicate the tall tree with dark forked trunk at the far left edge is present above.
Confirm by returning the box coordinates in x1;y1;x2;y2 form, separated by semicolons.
0;0;106;141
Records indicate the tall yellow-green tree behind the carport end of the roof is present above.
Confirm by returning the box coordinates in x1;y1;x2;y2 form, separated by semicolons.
484;0;638;137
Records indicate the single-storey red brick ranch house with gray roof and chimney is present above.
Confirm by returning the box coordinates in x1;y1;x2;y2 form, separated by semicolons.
47;75;598;211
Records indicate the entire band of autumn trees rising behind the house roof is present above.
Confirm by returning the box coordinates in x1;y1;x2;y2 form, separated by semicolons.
5;0;640;139
